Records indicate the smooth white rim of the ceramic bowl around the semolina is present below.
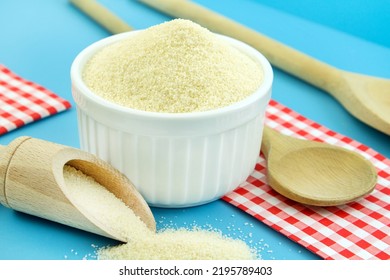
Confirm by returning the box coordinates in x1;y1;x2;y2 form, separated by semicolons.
70;29;273;119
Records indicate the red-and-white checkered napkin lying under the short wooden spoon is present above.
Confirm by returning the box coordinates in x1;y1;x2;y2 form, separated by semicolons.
223;101;390;260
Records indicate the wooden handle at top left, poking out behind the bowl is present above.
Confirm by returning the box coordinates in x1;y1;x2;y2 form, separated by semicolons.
70;0;133;34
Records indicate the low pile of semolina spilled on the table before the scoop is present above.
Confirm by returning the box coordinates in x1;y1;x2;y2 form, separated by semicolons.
99;228;256;260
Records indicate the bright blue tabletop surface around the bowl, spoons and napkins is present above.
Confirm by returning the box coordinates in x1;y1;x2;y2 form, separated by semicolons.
0;0;390;260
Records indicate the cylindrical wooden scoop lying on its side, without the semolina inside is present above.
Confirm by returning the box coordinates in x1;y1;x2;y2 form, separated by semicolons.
0;137;156;242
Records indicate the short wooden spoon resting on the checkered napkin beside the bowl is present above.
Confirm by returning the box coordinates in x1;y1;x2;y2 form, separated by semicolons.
261;127;377;206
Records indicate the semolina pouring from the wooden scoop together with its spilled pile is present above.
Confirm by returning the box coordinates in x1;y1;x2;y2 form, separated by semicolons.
64;165;256;260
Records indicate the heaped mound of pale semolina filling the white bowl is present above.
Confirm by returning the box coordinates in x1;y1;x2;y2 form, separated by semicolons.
83;19;263;113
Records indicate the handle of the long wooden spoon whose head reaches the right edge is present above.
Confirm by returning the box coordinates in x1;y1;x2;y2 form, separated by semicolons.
138;0;339;94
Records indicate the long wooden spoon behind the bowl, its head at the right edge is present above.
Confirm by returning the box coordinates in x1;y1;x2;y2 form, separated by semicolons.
139;0;390;135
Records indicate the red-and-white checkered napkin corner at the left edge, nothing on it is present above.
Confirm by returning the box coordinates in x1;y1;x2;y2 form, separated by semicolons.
0;65;71;135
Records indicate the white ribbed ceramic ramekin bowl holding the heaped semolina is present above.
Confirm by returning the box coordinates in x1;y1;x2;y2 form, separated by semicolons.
71;31;273;207
